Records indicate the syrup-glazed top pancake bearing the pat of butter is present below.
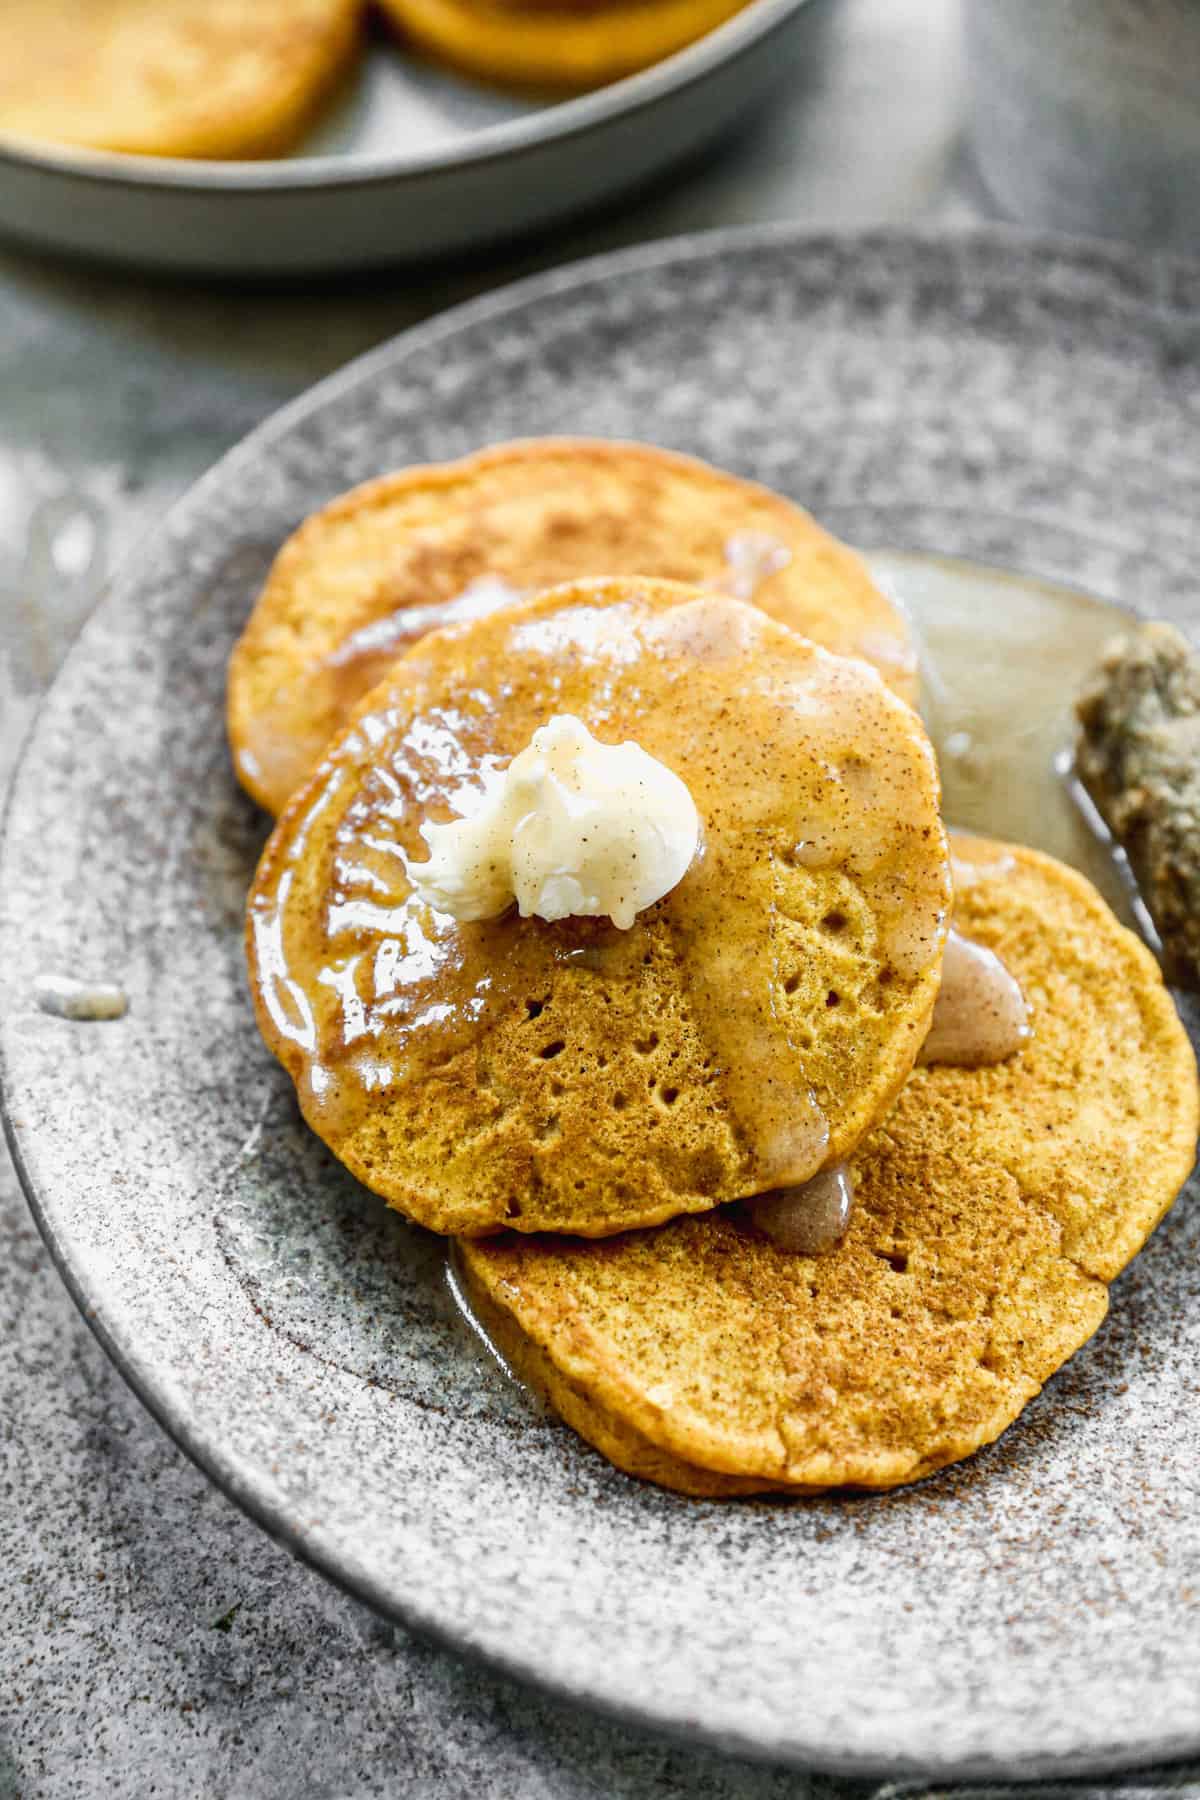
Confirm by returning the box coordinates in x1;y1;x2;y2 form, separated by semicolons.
248;580;950;1237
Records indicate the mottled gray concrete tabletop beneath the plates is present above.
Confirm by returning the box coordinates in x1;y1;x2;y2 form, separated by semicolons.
0;0;986;1800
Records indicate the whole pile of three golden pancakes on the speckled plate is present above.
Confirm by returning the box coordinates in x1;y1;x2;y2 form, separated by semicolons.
228;441;1198;1494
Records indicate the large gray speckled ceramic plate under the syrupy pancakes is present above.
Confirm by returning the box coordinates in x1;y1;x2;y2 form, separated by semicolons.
0;230;1200;1775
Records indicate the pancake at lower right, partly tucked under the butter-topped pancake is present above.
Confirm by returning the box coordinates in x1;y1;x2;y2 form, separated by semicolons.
462;839;1198;1494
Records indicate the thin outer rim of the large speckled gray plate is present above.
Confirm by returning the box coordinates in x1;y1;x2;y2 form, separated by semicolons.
0;221;1200;1782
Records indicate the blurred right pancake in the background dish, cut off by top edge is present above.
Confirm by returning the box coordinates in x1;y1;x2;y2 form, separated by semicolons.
381;0;747;88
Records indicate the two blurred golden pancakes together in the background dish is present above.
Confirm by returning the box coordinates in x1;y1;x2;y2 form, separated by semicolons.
0;0;745;158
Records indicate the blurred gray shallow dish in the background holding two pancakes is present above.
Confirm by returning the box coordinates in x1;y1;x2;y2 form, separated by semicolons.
0;0;820;275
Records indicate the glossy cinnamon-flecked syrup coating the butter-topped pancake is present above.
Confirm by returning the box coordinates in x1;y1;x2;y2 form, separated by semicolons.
252;599;945;1192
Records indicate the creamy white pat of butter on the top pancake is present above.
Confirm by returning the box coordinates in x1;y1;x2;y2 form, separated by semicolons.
408;713;700;931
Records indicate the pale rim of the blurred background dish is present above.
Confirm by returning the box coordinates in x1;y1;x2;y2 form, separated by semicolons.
0;0;817;194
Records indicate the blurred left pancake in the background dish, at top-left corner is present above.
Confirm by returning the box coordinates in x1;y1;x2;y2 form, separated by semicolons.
0;0;362;157
